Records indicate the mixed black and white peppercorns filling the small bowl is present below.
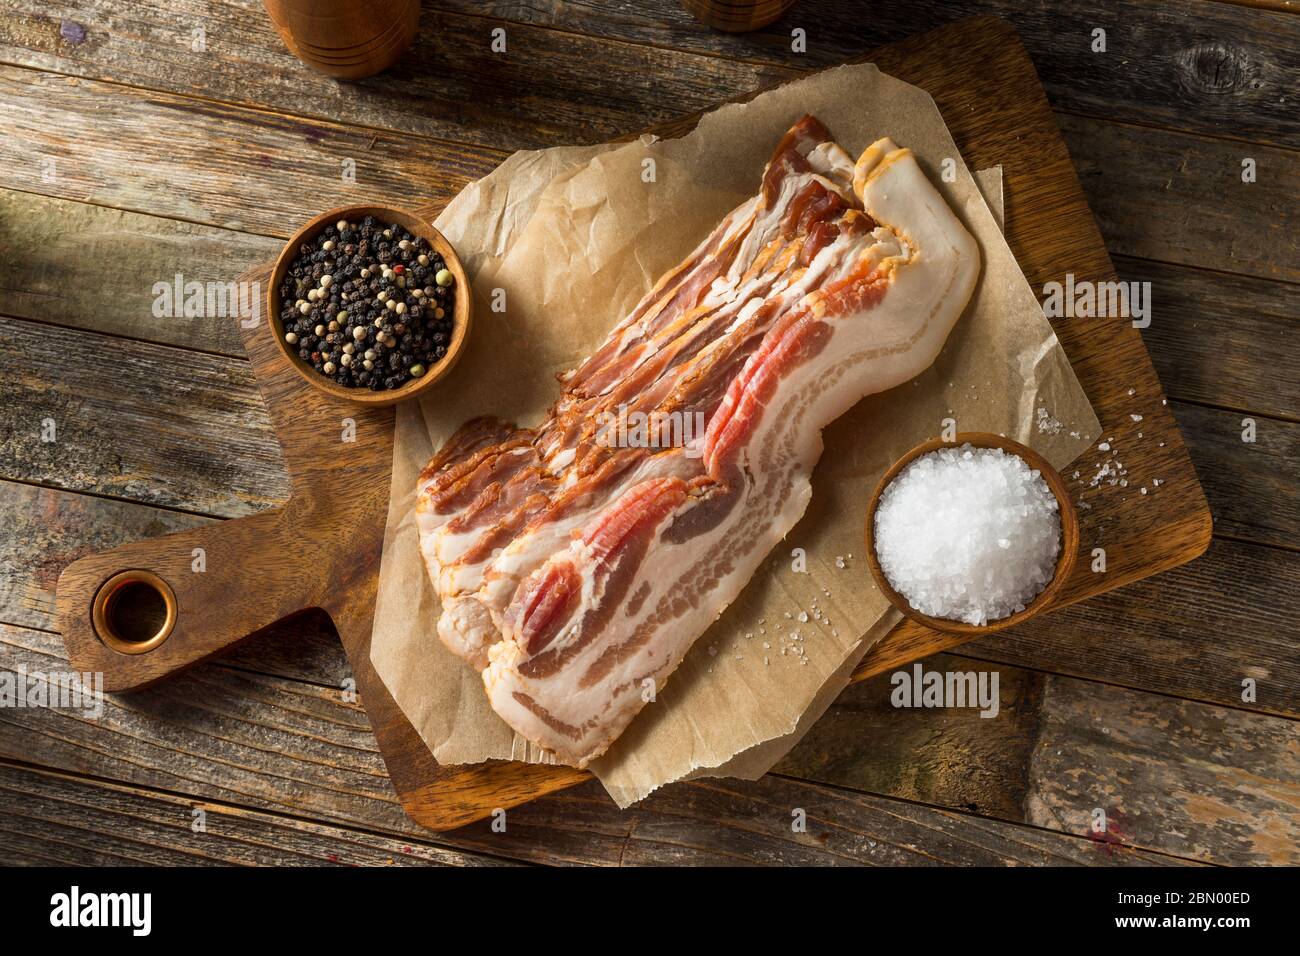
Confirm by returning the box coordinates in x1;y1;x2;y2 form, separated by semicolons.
280;216;456;390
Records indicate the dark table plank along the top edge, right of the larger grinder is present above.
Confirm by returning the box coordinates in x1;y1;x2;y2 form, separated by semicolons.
426;0;1300;147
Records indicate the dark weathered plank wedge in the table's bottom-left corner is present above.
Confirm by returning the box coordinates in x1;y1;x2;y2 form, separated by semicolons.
0;762;506;866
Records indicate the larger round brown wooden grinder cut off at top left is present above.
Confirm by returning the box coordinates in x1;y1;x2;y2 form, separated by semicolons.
263;0;420;79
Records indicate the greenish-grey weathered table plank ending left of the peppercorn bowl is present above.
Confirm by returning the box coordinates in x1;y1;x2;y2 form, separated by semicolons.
0;190;281;356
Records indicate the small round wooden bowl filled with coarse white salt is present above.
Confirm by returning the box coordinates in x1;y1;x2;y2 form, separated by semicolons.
866;432;1079;637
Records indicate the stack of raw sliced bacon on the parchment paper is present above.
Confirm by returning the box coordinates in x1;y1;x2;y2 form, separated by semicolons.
417;117;979;766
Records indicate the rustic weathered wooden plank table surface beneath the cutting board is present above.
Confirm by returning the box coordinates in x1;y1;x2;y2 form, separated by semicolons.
0;0;1300;866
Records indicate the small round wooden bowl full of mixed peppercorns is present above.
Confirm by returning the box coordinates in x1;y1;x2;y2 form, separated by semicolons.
267;206;472;405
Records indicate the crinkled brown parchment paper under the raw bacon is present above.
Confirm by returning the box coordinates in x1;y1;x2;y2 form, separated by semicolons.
371;65;1099;806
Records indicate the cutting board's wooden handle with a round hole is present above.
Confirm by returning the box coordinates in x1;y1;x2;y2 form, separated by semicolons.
57;509;313;691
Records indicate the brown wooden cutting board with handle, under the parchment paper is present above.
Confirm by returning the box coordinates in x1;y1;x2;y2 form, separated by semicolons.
59;17;1210;830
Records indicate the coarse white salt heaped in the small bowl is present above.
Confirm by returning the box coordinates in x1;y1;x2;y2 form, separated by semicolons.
874;445;1061;626
